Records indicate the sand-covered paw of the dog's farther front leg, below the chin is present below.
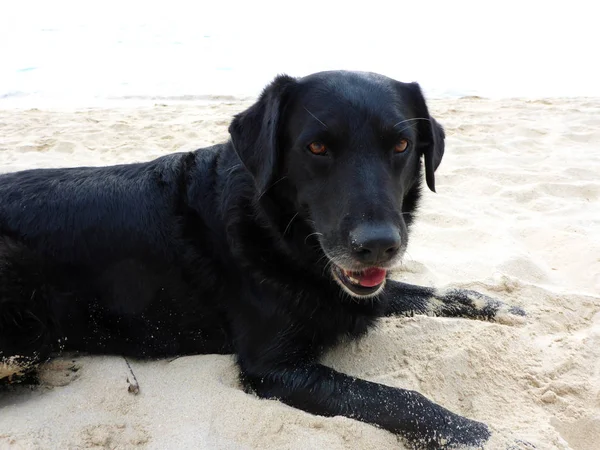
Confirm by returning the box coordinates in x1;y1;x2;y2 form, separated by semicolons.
436;289;526;325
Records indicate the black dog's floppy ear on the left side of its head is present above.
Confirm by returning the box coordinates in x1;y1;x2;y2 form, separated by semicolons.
229;75;296;193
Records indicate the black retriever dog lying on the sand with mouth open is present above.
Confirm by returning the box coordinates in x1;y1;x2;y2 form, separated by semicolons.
0;71;523;448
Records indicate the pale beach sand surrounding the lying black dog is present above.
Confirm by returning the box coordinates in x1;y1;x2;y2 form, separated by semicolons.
0;98;600;450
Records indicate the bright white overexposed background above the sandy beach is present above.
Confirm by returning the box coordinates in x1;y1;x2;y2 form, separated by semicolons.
0;0;600;96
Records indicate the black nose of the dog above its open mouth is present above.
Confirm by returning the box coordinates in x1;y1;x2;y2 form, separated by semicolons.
350;225;401;265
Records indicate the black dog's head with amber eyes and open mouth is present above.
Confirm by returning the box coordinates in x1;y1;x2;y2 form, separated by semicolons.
229;71;444;297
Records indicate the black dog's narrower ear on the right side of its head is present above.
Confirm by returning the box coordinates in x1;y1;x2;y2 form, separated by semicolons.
401;83;446;192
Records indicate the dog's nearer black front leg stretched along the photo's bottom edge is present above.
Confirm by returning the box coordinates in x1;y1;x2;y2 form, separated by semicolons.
242;364;490;449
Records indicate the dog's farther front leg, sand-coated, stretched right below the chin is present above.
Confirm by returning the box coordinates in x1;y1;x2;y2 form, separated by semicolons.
382;280;525;323
